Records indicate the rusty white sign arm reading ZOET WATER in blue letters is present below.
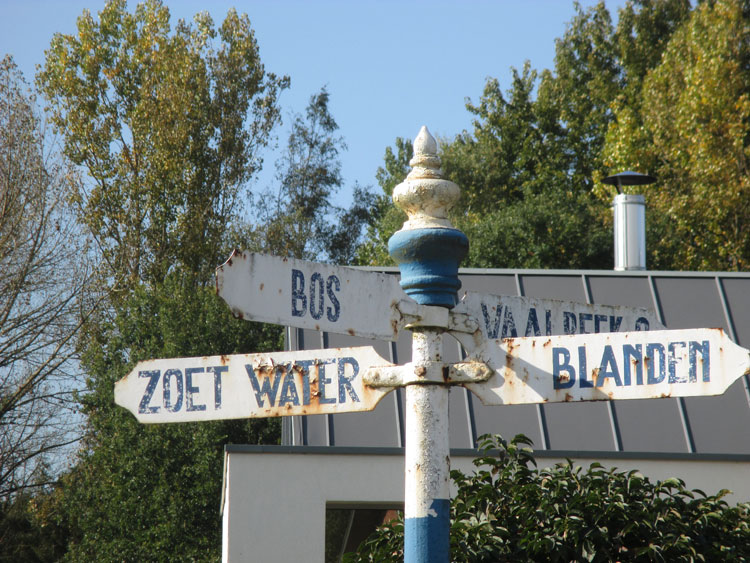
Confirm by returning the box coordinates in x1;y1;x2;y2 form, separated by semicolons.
115;346;390;423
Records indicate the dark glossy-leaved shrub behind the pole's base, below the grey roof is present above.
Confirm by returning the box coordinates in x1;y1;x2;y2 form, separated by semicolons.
346;435;750;562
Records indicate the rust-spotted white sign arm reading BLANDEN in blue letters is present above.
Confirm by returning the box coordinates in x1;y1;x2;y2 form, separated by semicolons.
465;329;750;405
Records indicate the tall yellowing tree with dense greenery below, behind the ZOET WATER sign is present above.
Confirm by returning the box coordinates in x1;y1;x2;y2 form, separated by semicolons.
33;0;288;561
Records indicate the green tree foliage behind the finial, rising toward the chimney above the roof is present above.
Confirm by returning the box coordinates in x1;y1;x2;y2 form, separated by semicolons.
359;0;708;268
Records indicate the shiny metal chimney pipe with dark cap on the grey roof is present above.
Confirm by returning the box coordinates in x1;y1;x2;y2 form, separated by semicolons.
602;171;656;271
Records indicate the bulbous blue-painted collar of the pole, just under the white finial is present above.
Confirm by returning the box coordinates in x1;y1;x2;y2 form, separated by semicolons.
388;228;469;308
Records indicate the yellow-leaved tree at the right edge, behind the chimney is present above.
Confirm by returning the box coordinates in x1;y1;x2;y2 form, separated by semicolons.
605;0;750;270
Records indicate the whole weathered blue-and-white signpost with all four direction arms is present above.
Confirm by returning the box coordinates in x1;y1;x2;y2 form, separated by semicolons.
115;128;750;563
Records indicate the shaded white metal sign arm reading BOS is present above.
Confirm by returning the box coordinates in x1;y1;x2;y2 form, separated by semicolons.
216;251;407;340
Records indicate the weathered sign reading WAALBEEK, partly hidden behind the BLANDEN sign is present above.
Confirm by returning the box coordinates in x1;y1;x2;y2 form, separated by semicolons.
454;291;664;339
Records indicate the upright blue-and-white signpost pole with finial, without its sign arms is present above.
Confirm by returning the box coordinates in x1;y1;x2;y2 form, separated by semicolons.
388;127;469;563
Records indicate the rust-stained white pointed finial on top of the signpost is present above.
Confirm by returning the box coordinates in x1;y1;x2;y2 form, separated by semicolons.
393;126;461;231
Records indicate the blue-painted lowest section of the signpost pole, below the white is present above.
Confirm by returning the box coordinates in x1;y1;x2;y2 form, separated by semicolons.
404;499;450;563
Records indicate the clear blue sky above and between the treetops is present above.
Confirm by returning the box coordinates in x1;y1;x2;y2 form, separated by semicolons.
0;0;625;205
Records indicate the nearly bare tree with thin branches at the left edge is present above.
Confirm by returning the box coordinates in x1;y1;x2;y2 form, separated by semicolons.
0;57;89;504
